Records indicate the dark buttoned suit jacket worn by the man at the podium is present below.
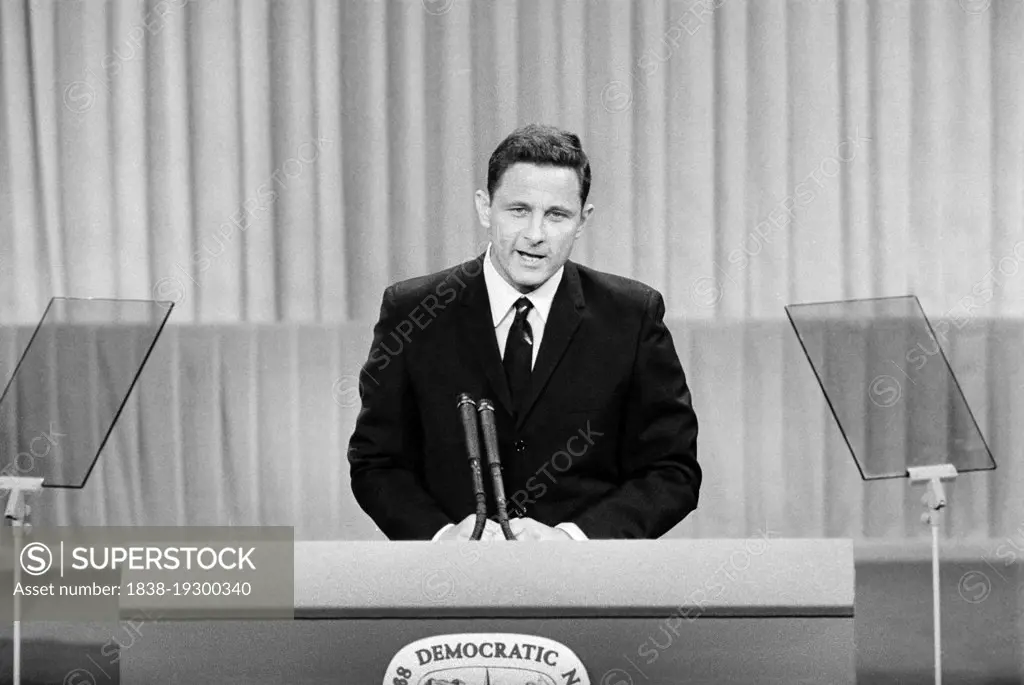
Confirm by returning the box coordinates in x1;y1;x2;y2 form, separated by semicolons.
348;255;701;540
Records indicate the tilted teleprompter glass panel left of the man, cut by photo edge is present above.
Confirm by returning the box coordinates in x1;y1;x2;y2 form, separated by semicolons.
0;297;174;487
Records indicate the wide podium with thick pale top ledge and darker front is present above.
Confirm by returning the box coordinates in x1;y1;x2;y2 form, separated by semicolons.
119;536;856;685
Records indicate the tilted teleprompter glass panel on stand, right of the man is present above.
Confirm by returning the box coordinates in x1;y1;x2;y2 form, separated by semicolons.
785;295;995;480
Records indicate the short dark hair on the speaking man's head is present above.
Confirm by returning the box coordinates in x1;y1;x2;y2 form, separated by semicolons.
487;124;590;206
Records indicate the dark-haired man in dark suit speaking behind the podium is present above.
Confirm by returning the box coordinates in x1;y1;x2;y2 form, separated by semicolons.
348;125;701;540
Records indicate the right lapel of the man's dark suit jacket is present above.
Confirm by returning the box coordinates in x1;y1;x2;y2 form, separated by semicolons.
516;261;585;430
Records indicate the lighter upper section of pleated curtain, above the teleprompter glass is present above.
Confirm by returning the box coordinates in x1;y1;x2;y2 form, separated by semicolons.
0;0;1024;323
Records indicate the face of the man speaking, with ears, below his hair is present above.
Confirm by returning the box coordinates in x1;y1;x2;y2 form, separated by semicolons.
476;163;594;293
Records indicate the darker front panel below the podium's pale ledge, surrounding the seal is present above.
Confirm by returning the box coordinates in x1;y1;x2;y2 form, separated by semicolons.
121;617;856;685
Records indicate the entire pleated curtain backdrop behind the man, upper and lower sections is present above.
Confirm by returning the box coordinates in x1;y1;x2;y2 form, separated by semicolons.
0;0;1024;538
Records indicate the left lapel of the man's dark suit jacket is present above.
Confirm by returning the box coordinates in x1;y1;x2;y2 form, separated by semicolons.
458;253;512;414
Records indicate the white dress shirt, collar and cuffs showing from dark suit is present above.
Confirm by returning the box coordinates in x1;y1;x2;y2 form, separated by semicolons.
434;244;587;540
